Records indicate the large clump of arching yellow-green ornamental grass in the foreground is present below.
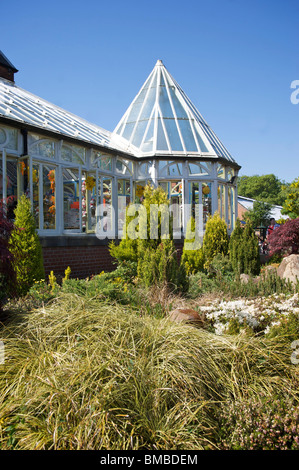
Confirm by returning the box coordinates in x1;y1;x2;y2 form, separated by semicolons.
0;293;298;450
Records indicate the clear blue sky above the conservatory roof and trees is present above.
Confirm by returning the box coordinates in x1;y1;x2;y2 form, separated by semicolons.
0;0;299;181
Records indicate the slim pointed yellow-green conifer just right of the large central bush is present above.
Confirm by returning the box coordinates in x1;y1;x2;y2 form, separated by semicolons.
181;217;204;275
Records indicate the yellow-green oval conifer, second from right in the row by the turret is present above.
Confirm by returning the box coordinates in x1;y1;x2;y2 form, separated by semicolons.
203;212;229;267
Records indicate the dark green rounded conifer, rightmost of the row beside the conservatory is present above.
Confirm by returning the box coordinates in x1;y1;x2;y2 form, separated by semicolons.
229;219;260;275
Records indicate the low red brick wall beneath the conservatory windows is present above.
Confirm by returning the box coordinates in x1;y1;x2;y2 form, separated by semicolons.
43;245;115;278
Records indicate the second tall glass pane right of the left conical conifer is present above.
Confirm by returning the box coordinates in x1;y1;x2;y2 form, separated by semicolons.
62;168;80;230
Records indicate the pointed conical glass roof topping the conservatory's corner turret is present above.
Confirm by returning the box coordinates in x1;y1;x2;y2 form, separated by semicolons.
112;60;234;162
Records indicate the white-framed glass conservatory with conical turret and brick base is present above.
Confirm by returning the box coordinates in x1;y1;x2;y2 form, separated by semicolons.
0;52;240;277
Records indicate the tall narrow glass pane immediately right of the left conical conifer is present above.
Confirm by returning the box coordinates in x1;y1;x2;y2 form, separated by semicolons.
43;165;56;229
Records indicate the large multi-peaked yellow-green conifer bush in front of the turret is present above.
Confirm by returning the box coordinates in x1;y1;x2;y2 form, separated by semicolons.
109;185;187;289
